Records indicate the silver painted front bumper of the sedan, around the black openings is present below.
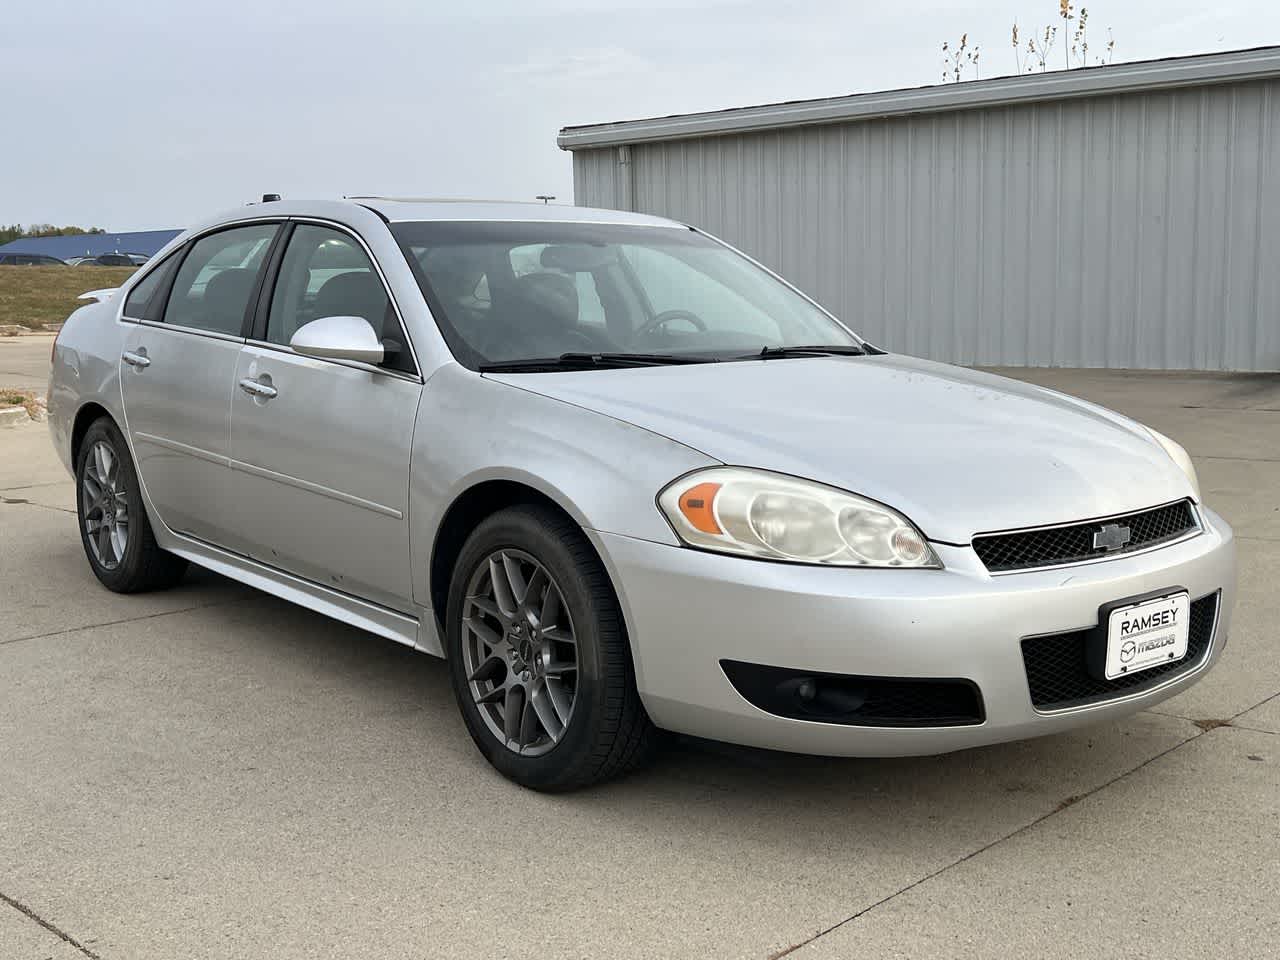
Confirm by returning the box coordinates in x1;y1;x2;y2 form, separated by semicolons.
591;507;1235;756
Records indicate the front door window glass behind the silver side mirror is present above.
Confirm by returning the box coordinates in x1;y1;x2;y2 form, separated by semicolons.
266;224;413;372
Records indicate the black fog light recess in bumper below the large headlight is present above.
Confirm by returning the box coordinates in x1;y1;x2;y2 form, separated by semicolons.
721;660;983;727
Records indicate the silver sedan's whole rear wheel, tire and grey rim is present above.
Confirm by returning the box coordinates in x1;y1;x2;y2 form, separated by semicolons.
76;417;187;594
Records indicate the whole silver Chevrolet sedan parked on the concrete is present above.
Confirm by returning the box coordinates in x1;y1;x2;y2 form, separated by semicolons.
49;198;1235;790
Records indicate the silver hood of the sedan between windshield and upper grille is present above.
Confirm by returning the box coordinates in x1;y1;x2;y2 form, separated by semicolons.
490;355;1193;544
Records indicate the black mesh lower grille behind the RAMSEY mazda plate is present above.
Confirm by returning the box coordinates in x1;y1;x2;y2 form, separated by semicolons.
1023;593;1219;709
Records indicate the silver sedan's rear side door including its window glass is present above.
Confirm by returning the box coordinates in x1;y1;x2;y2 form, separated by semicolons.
120;223;279;549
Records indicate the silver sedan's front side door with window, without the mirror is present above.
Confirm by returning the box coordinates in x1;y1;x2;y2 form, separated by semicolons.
222;223;421;608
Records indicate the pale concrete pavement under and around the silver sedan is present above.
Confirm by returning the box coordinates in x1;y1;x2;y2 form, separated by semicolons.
0;371;1280;960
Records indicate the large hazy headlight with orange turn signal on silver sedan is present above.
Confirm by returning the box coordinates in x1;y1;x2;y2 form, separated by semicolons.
658;467;942;567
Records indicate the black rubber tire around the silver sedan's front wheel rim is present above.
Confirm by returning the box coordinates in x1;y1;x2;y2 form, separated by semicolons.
445;506;660;792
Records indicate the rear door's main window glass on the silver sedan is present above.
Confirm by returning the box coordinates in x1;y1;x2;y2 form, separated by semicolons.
164;224;278;337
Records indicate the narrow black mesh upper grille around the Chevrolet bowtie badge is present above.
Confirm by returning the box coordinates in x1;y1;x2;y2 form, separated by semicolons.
973;500;1196;572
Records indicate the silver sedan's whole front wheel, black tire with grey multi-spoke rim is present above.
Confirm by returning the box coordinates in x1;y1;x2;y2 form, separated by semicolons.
445;506;658;791
